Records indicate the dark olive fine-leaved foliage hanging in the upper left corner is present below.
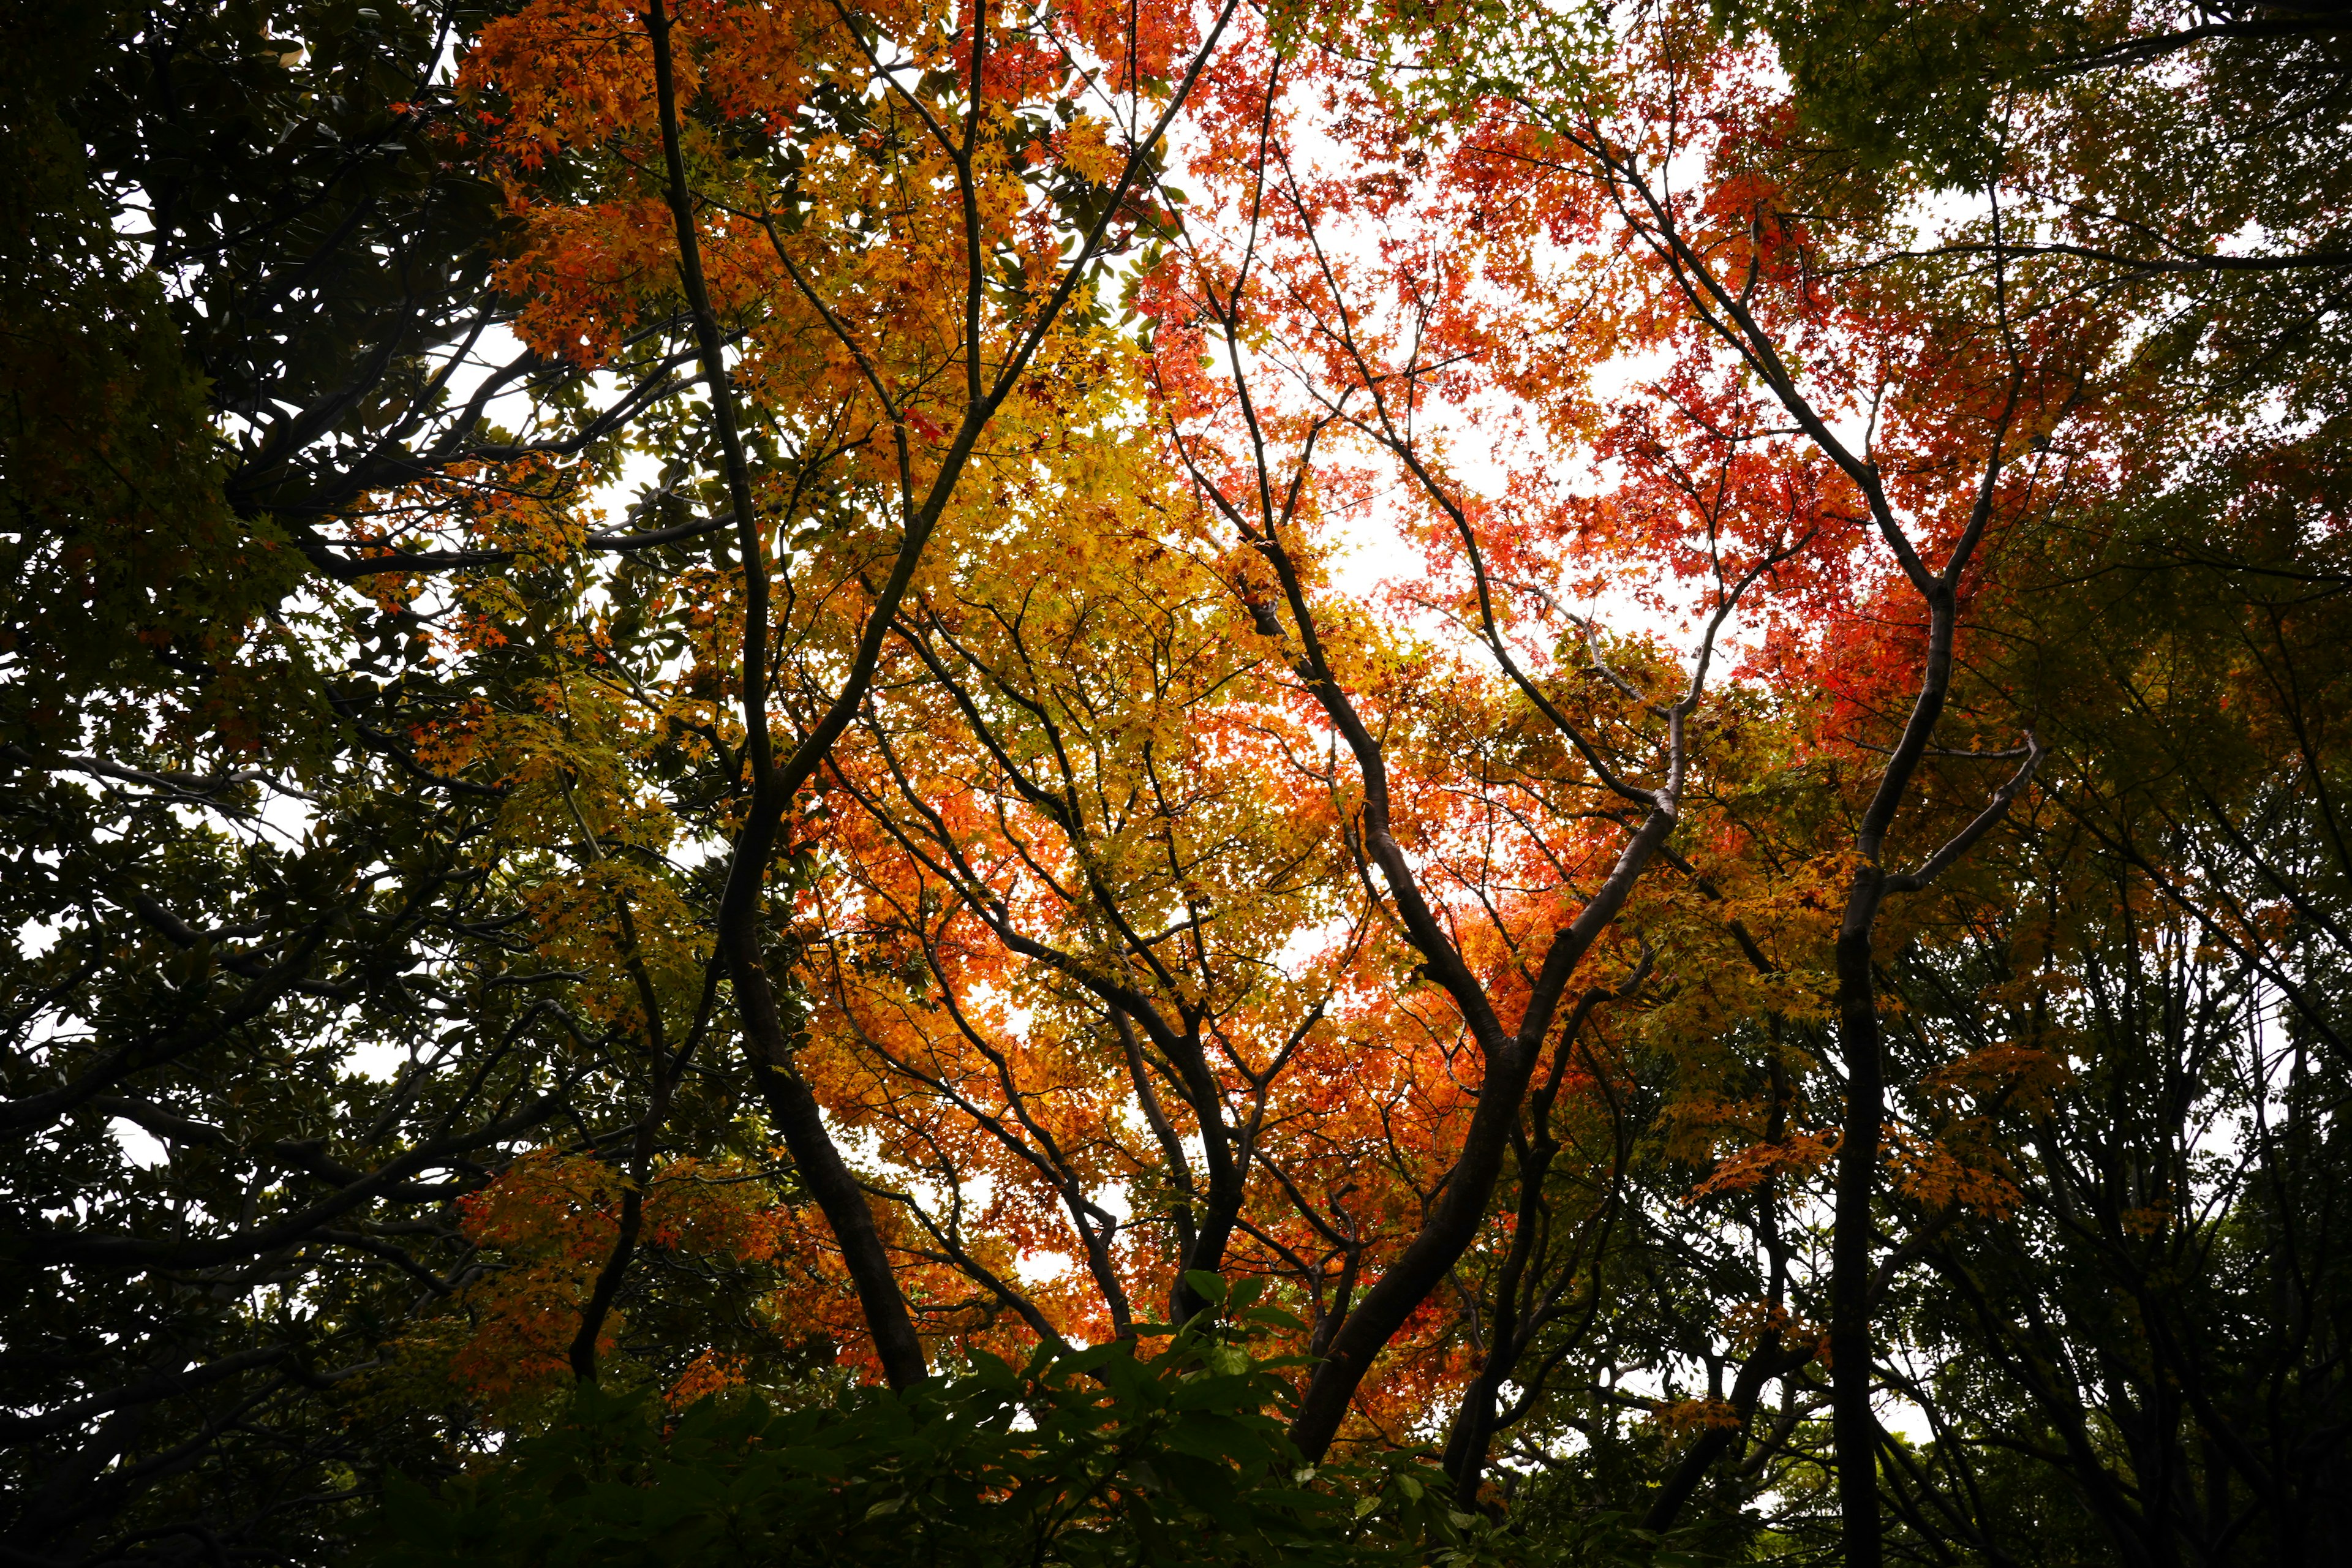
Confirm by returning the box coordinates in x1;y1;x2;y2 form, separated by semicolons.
0;7;301;745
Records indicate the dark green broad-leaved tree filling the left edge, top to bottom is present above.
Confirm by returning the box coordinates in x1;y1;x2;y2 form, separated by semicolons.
0;7;644;1554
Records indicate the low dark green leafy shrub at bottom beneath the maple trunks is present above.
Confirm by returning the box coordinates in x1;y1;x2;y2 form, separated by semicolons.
364;1306;1496;1568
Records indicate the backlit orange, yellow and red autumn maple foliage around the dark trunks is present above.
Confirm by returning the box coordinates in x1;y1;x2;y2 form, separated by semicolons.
413;0;2108;1457
